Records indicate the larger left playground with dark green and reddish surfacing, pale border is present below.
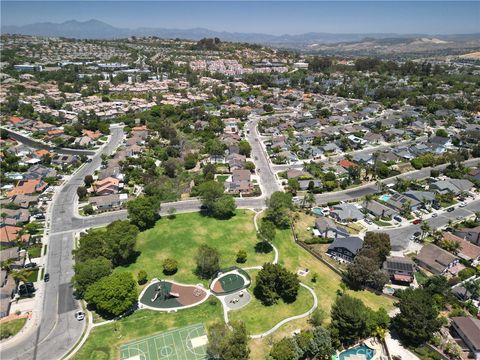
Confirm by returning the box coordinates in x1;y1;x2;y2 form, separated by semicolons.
139;279;208;310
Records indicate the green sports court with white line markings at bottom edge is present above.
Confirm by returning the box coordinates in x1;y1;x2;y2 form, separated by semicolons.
120;324;208;360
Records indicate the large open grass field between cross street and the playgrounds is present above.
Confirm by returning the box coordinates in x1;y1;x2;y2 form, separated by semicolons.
115;210;273;285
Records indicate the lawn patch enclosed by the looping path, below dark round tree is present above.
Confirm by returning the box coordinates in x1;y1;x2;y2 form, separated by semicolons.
228;273;313;335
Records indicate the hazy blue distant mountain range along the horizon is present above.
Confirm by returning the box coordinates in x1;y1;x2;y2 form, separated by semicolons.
1;19;480;47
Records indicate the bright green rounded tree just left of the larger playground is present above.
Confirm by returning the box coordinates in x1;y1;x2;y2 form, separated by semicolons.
85;272;138;317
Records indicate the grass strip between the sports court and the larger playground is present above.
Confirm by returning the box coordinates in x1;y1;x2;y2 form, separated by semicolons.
74;297;223;360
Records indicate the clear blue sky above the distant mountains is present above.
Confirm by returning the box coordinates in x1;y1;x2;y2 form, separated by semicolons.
1;1;480;35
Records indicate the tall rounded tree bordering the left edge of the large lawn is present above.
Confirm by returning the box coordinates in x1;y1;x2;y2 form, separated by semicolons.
105;220;139;266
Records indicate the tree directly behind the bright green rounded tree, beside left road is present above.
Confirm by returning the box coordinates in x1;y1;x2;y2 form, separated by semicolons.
73;256;112;297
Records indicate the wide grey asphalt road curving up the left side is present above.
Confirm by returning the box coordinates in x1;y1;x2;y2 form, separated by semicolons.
1;128;123;360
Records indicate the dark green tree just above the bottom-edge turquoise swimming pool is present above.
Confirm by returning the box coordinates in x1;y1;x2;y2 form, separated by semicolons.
331;294;368;346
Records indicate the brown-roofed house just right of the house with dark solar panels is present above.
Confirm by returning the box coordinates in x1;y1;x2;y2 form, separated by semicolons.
415;244;465;275
